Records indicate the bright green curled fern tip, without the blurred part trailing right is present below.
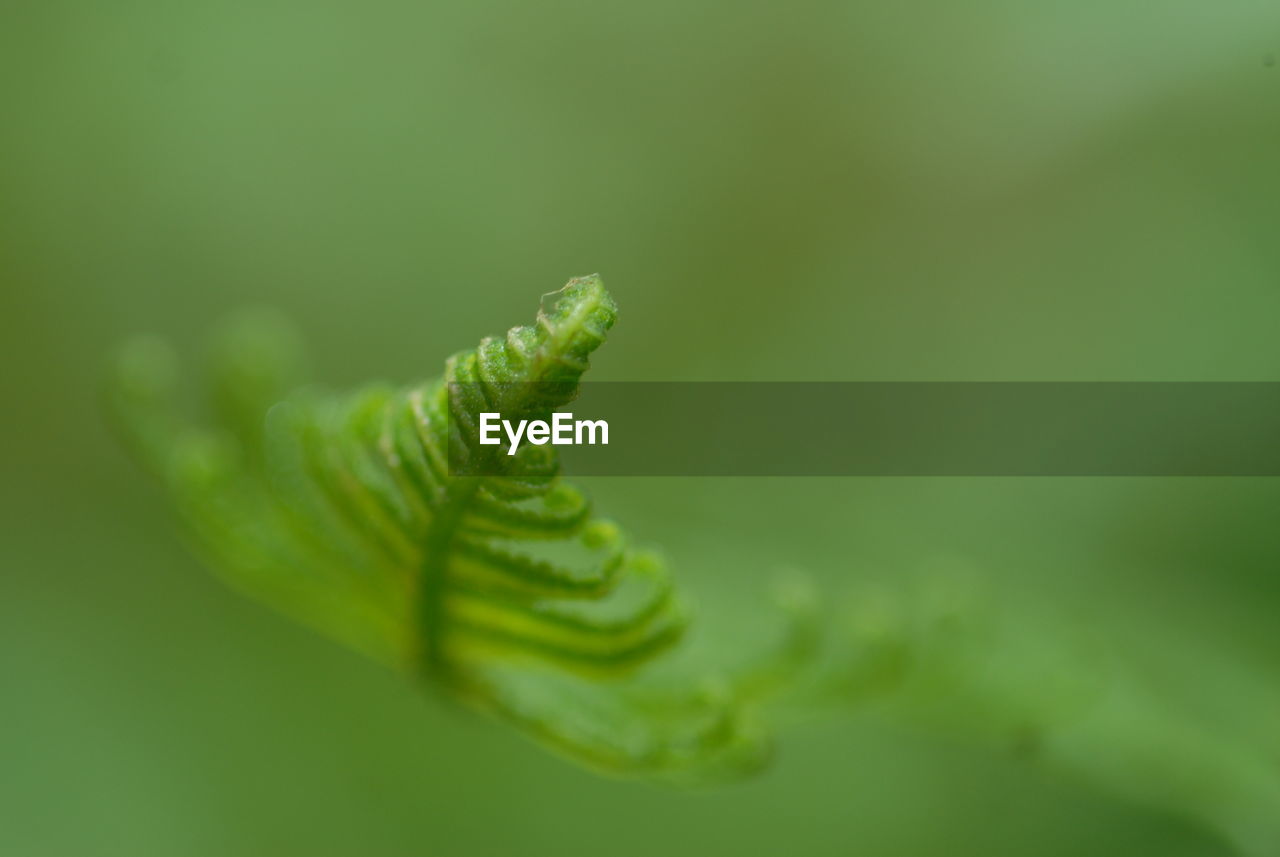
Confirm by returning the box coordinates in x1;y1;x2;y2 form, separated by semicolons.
113;276;804;779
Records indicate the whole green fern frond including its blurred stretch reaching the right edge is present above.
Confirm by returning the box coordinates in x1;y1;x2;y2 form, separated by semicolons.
104;276;1280;857
